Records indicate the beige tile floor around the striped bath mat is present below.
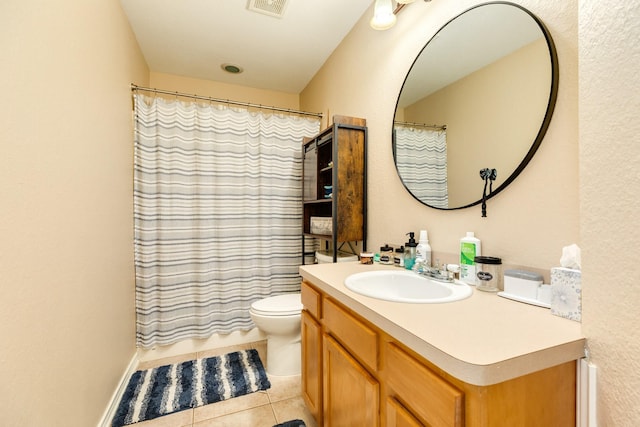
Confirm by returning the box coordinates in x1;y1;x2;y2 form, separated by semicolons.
120;341;317;427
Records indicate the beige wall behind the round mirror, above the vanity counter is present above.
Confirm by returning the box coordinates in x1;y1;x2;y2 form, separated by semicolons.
300;0;579;272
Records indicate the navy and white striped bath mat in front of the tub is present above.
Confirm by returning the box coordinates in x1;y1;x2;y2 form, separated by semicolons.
111;349;271;427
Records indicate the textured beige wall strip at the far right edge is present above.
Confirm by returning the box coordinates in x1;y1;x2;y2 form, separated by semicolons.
579;0;640;426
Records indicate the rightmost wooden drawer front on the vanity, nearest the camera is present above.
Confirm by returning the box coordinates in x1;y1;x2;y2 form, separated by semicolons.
384;343;464;427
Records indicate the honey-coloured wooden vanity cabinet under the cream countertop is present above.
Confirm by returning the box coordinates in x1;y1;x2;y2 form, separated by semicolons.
301;280;576;427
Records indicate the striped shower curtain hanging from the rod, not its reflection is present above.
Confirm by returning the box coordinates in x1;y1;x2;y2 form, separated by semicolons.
134;94;319;348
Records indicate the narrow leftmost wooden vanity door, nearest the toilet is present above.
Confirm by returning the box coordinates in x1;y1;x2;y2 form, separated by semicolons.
301;310;322;425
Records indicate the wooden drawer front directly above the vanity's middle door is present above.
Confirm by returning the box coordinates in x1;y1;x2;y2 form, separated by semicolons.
322;298;378;372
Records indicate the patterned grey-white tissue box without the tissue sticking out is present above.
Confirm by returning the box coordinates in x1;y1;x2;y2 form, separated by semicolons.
551;267;582;322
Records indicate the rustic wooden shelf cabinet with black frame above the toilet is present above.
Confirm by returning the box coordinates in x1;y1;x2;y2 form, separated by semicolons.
302;116;367;264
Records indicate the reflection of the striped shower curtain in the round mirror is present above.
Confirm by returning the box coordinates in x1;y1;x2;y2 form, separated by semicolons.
394;125;449;208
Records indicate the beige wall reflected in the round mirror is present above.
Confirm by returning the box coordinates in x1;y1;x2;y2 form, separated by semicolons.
404;38;551;207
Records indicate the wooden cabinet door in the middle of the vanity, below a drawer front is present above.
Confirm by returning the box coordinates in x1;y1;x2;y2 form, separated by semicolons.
323;335;380;427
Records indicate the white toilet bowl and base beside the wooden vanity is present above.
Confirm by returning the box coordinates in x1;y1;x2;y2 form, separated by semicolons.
249;293;302;376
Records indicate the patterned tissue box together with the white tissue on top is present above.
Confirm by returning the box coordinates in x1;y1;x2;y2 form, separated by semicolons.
551;244;582;322
